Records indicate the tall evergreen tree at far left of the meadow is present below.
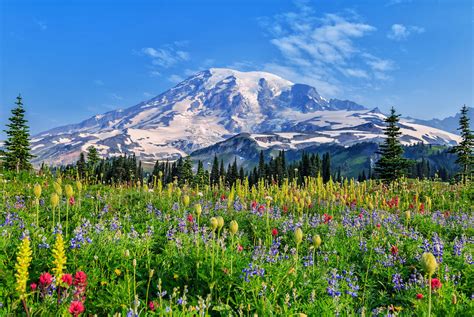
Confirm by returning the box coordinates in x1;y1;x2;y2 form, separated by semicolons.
4;95;34;173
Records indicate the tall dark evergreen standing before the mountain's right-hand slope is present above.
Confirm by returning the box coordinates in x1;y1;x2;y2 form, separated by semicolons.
375;107;410;182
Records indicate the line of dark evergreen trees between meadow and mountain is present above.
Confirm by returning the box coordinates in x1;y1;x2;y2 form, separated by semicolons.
0;95;474;185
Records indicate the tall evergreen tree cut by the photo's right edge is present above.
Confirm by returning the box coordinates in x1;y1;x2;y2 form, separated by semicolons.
451;105;474;183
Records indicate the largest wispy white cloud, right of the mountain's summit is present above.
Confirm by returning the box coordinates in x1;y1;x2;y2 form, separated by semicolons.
260;2;394;97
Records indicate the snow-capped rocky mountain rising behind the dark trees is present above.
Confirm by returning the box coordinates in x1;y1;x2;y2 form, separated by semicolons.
32;68;458;164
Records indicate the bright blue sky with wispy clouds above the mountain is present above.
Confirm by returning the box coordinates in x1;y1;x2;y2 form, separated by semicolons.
0;0;474;136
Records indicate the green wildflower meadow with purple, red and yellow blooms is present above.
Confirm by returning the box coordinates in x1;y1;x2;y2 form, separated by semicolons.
0;174;474;316
